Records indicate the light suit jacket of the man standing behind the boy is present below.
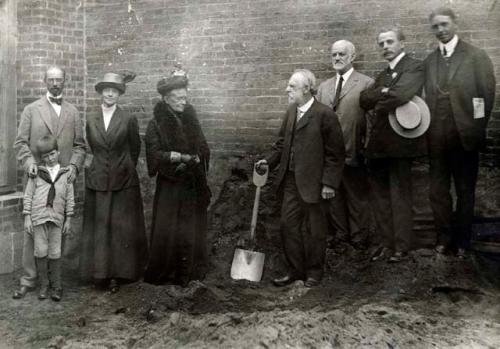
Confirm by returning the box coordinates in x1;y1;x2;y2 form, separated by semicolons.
14;95;86;171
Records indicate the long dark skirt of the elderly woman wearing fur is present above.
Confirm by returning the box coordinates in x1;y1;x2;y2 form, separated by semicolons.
144;177;208;284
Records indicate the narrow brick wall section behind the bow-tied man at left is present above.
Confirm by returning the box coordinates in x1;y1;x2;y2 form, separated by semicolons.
17;0;85;202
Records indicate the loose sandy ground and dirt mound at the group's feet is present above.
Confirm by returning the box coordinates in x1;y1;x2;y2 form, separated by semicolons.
0;164;500;349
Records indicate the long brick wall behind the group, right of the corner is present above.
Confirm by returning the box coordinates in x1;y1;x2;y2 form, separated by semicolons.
86;0;500;160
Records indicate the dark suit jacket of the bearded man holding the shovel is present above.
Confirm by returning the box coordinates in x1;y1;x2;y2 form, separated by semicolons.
266;100;345;203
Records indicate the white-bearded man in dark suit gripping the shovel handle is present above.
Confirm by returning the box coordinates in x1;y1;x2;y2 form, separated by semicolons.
256;69;345;287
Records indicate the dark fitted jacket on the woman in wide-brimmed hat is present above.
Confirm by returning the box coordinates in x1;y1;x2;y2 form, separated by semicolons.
85;106;141;191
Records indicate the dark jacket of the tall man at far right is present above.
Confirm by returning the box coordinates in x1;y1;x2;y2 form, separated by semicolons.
424;40;495;151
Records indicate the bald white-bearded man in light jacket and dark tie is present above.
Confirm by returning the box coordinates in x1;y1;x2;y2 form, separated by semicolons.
316;40;373;248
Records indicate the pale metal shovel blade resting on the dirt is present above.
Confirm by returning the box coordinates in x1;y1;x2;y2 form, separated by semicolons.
231;248;265;282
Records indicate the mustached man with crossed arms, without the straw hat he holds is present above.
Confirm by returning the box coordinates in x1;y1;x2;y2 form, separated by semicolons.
360;28;426;262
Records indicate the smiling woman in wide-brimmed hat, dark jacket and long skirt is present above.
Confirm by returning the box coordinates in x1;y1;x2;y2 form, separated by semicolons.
82;73;147;292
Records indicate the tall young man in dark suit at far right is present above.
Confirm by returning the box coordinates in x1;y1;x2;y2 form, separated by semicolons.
424;8;495;258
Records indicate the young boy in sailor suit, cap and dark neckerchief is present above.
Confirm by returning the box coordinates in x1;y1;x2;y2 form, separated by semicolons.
23;135;75;302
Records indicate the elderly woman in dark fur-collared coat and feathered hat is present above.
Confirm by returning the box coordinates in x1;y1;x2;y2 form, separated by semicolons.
144;71;210;286
